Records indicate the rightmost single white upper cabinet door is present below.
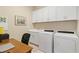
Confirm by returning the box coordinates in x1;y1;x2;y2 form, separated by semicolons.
64;6;77;20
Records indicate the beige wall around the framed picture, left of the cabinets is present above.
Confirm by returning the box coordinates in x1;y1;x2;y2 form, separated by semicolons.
0;6;32;40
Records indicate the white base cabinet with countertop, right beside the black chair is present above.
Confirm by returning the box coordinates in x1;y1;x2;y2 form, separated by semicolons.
29;29;44;45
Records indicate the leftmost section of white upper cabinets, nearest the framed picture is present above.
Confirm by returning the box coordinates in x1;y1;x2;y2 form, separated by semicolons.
32;7;48;22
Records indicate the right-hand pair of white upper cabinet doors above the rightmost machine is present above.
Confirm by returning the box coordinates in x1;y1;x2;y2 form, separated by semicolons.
57;6;77;20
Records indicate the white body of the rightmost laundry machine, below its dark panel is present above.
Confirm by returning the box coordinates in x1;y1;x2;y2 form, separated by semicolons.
54;33;78;53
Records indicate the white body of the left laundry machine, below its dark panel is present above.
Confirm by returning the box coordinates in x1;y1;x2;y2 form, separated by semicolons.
39;32;54;53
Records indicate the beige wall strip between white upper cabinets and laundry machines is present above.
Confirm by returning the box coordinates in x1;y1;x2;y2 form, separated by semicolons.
33;20;77;32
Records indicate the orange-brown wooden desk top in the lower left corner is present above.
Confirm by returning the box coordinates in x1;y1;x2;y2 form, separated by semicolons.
0;39;32;53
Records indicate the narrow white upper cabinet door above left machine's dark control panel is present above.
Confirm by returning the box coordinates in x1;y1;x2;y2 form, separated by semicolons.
48;6;56;21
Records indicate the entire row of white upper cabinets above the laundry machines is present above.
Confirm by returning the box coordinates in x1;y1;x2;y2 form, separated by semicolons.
32;6;77;22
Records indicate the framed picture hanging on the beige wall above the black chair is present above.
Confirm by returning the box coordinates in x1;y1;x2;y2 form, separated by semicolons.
15;15;26;26
